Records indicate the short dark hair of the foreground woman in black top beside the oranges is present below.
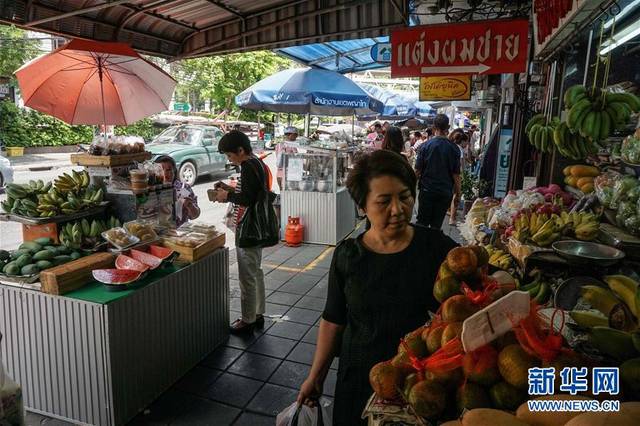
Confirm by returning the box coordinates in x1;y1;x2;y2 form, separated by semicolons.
347;150;417;209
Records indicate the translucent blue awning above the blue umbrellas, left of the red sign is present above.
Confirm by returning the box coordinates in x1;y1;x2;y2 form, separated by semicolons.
276;37;389;74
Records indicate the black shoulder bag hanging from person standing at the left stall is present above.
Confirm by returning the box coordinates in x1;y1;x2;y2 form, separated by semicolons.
236;158;280;248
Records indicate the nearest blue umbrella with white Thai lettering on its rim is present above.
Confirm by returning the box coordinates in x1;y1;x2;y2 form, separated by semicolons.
236;68;383;115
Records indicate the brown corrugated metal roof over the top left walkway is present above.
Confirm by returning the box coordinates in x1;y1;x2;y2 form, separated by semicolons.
0;0;409;61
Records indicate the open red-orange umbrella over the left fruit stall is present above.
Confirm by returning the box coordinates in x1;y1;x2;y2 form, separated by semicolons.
15;40;176;125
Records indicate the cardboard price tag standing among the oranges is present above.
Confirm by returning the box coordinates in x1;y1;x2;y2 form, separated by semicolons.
461;291;531;352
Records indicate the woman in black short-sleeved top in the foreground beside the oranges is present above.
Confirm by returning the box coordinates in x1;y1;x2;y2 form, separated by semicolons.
298;150;456;426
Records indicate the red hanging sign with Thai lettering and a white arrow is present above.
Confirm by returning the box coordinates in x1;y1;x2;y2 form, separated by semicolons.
391;19;529;77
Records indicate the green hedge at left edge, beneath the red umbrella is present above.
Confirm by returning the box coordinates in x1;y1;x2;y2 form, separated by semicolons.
0;101;93;147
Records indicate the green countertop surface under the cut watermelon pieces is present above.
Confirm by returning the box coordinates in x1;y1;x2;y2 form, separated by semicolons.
64;263;188;305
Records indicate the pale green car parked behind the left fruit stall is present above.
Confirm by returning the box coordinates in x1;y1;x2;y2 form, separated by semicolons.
146;124;233;185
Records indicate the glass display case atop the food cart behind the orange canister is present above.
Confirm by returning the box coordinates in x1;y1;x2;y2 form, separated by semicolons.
283;147;355;193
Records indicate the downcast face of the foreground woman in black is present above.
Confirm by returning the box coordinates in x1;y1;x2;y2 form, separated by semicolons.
365;176;414;237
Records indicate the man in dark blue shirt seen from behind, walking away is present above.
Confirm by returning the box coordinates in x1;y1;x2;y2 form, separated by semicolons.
416;114;460;229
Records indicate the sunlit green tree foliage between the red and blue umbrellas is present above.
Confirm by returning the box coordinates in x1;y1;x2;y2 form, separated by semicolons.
171;51;293;116
